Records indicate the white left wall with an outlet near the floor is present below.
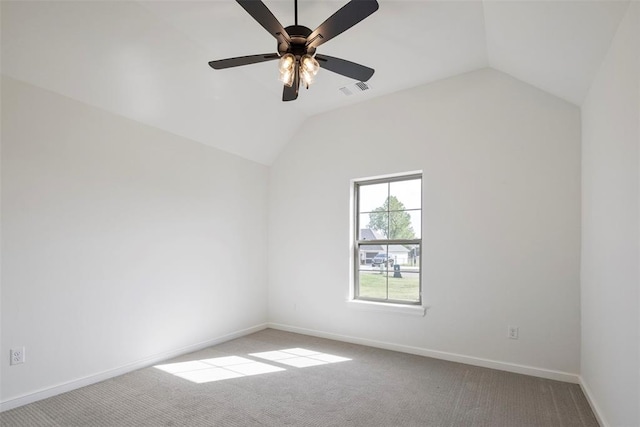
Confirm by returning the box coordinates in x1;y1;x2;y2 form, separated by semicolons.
0;78;268;407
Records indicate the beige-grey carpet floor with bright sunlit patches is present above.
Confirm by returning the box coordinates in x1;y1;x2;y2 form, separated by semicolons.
0;329;598;427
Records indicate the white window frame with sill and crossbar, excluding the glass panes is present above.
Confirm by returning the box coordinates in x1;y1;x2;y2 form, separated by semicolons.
349;171;426;315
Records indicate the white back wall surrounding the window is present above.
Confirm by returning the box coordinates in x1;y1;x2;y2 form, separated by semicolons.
269;69;580;374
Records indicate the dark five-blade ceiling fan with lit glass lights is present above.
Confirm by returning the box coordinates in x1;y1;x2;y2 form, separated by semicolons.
209;0;378;101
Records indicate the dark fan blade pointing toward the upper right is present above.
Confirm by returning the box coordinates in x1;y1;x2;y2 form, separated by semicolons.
307;0;378;47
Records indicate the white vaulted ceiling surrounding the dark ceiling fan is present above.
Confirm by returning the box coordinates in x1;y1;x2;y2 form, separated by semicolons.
1;0;629;164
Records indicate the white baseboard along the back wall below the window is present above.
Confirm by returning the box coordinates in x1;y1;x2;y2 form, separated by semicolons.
267;323;581;384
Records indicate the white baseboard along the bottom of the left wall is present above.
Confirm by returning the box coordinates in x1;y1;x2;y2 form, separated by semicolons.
0;323;267;412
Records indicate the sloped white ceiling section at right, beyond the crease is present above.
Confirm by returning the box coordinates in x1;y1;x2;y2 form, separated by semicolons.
484;1;629;105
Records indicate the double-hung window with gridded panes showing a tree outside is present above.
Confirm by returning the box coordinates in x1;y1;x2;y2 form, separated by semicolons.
354;174;422;305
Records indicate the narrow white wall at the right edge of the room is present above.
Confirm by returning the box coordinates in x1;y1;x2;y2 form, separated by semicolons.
581;2;640;426
